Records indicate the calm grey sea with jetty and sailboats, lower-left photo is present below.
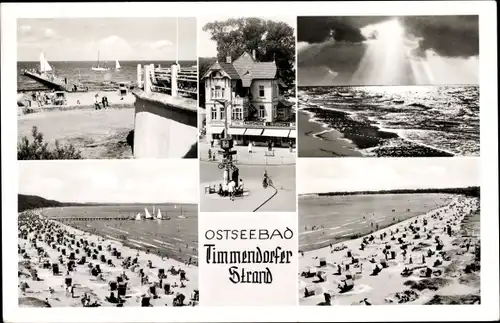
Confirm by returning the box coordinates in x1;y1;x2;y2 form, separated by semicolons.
43;203;198;262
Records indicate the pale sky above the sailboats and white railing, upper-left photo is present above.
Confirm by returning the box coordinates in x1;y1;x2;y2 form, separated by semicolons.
17;18;197;61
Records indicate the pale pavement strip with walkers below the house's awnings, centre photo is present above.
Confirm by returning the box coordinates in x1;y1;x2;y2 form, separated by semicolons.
199;139;297;165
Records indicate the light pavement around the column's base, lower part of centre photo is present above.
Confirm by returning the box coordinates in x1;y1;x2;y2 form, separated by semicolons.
200;161;297;212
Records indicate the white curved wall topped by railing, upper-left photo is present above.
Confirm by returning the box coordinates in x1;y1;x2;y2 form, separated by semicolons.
132;64;198;158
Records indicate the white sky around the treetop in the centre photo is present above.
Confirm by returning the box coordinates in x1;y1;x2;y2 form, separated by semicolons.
198;16;297;57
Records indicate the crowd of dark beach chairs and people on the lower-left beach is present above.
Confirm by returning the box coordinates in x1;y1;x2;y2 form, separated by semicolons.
18;211;197;307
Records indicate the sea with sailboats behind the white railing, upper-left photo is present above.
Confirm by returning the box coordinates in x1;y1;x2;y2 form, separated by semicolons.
17;61;197;92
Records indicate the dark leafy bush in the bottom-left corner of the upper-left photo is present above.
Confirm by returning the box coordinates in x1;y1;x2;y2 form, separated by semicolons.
17;126;82;160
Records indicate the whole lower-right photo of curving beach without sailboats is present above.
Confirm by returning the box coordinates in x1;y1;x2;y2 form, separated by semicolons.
298;158;482;306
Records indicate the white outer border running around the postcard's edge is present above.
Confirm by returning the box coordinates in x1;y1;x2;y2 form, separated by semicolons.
1;1;500;322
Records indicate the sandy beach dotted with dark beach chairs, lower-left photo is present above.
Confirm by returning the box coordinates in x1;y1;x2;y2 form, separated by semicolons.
18;211;198;307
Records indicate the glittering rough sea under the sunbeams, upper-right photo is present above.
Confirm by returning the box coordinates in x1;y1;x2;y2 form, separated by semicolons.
299;85;480;156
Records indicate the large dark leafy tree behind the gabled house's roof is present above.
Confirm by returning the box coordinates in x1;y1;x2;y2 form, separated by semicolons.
200;18;295;89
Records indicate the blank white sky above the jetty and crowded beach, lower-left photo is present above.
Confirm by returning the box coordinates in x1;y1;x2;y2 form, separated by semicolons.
19;159;199;203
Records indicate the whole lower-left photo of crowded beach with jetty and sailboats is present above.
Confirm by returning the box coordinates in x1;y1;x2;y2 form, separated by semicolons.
17;159;199;308
